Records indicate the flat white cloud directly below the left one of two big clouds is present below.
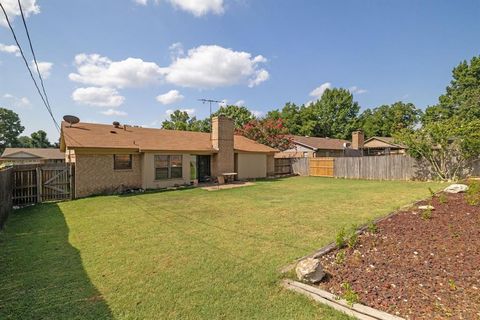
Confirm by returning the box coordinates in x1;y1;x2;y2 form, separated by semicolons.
72;87;125;107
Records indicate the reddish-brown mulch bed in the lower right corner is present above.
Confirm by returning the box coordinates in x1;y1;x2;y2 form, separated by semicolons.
319;194;480;319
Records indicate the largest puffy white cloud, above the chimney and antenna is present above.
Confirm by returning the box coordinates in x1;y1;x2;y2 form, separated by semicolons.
162;45;269;88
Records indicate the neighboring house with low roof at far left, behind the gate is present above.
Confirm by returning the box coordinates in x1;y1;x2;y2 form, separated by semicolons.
0;148;65;164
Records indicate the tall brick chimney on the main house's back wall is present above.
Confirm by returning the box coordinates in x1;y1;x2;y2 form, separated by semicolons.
211;116;235;177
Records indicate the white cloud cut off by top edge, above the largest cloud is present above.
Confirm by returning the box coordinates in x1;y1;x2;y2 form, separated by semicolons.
133;0;225;17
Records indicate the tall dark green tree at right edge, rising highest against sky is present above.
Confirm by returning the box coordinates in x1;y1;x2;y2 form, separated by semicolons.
422;56;480;123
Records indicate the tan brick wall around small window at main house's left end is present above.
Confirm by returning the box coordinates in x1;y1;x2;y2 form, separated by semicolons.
75;153;142;198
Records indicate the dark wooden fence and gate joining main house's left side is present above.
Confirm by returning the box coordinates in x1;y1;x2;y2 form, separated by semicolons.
12;164;74;205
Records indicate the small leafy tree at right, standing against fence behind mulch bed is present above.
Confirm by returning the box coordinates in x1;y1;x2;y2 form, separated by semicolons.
395;116;480;180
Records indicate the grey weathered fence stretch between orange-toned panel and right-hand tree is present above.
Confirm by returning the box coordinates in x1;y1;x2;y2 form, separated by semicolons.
334;155;418;180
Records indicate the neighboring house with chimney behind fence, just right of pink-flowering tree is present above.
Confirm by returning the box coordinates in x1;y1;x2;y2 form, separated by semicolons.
275;131;363;158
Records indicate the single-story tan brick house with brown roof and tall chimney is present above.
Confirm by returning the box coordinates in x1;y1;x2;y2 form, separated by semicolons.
60;116;277;197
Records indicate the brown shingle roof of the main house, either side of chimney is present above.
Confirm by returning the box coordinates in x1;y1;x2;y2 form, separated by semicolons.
61;122;277;153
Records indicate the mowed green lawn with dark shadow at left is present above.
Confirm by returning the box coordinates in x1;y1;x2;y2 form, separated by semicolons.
0;177;440;319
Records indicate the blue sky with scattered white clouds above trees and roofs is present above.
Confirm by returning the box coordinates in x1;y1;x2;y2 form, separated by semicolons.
0;0;480;141
